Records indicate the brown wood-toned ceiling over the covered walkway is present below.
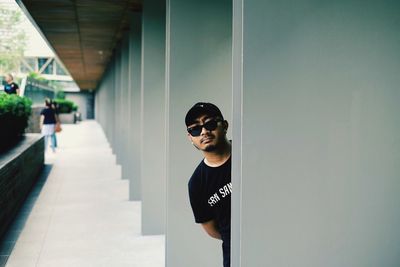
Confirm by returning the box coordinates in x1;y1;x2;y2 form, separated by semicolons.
17;0;142;90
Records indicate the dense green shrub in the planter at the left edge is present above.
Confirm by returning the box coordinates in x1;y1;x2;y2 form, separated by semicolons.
0;93;32;149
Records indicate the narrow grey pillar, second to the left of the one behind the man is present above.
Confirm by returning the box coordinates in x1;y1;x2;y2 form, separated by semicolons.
129;12;142;200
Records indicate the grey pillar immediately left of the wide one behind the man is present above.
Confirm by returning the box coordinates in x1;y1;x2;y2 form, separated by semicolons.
141;0;166;235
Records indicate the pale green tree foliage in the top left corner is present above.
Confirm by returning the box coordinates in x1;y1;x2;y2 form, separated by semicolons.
0;3;27;73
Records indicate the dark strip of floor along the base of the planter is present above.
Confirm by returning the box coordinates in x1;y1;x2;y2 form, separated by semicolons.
0;164;53;267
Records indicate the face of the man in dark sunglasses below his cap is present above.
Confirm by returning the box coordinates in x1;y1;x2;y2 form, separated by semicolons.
188;115;226;152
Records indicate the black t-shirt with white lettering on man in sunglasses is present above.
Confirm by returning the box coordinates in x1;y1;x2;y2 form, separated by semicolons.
188;158;232;245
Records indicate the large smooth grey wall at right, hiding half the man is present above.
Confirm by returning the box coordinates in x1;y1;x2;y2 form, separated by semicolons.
233;0;400;267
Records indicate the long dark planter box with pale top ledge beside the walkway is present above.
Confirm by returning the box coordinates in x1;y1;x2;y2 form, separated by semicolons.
0;134;44;238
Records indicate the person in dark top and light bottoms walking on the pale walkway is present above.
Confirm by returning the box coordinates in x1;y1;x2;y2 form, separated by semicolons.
40;99;57;152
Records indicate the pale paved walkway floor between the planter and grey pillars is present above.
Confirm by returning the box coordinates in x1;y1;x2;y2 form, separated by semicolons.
6;121;164;267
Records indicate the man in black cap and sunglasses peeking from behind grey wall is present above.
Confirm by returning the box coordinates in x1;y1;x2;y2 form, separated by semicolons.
185;102;232;267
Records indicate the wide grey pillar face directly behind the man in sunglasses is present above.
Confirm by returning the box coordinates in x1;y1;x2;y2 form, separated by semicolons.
166;0;232;267
